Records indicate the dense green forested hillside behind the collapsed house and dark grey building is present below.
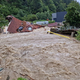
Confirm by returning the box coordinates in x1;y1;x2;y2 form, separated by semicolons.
0;0;73;20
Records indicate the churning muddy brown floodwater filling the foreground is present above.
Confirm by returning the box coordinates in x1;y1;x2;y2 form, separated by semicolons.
0;27;80;80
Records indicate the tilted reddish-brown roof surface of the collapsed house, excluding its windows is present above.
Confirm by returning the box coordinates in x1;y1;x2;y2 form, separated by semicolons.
6;16;32;33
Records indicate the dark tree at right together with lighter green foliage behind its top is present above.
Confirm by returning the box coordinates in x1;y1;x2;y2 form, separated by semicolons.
65;1;80;27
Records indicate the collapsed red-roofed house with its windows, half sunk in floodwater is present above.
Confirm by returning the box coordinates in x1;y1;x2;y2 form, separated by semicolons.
6;15;43;33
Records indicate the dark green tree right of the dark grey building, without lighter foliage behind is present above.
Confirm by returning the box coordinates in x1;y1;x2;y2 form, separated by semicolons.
65;6;80;27
